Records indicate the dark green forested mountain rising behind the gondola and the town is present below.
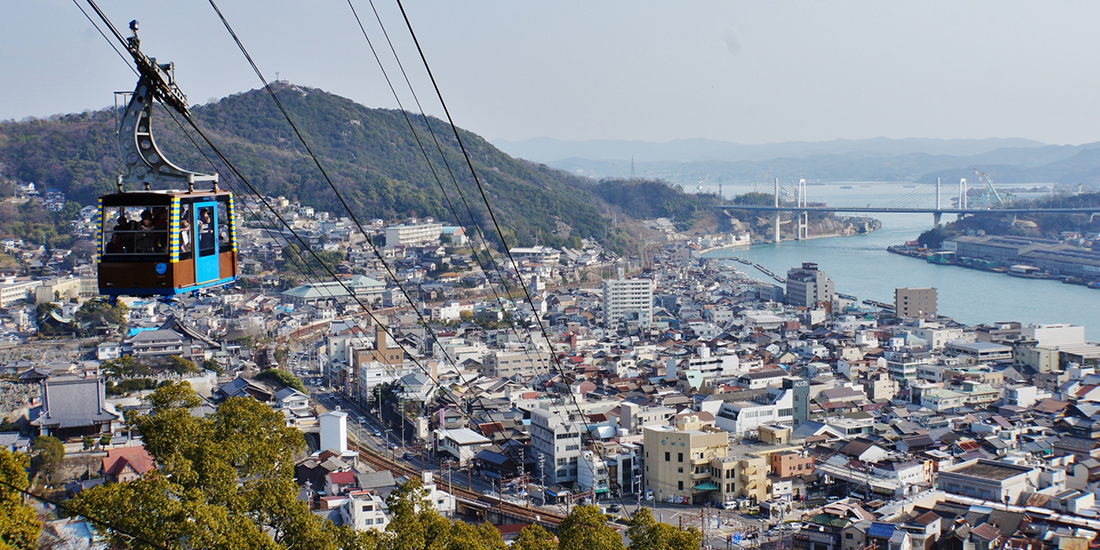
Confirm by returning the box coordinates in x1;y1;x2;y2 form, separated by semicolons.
0;83;608;245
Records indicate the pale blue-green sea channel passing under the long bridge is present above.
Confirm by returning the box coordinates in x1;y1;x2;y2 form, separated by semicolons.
705;183;1100;341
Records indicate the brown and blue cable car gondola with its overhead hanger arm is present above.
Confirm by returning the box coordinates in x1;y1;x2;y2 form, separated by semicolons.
97;21;237;297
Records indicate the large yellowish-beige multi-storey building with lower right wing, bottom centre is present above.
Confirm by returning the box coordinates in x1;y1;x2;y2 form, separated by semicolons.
642;417;768;504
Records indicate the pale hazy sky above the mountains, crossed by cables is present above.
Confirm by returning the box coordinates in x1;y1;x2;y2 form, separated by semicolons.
0;0;1100;144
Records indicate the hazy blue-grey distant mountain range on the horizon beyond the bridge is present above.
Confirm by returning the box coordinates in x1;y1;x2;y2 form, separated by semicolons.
494;138;1100;188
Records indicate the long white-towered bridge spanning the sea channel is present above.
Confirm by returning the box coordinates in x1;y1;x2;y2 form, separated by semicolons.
717;178;1100;242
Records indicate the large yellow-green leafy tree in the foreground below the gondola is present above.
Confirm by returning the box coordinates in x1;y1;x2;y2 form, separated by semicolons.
74;383;321;550
